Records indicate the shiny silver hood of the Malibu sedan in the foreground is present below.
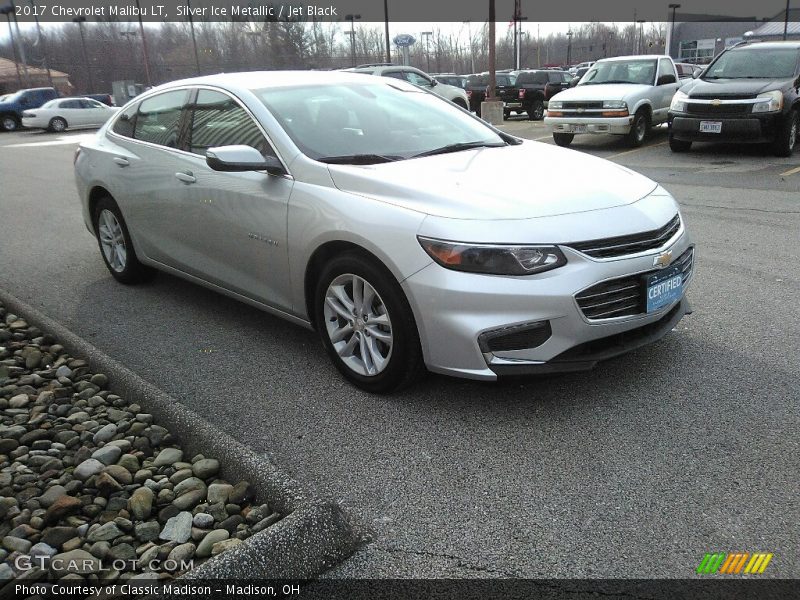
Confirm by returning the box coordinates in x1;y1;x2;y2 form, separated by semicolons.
328;141;656;220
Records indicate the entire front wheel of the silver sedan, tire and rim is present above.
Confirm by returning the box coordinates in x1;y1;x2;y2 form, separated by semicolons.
314;252;424;393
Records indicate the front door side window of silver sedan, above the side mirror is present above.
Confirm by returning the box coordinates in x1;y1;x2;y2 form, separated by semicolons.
189;90;275;156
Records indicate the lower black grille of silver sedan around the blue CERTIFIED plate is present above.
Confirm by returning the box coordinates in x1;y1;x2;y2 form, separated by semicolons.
575;248;694;320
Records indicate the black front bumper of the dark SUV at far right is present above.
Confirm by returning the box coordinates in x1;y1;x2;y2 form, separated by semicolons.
668;113;783;144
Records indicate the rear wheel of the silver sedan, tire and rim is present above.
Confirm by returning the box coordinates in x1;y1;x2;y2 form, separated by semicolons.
93;196;155;284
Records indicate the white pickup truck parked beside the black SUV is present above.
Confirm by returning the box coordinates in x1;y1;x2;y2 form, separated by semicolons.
544;55;680;146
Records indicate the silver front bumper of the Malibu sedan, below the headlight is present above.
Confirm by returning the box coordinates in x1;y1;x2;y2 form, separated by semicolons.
403;229;693;380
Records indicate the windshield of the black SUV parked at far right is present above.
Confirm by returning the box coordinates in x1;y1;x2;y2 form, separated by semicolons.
703;48;798;79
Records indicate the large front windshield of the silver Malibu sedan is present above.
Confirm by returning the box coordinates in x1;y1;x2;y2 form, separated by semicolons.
255;82;505;162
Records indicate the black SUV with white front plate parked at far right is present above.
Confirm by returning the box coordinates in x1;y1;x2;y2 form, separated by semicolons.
669;42;800;156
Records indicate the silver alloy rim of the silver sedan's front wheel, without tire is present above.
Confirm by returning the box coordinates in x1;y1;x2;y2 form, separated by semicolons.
323;273;394;377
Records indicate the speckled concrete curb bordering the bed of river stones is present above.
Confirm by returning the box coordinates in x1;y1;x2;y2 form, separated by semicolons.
0;289;361;579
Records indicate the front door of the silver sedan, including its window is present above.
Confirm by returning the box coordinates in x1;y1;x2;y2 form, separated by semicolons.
181;88;294;309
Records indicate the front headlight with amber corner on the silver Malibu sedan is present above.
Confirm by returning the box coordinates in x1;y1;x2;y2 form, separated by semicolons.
417;236;567;275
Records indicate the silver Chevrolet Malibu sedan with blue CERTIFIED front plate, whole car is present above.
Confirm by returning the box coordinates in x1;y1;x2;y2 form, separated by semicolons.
75;72;694;392
